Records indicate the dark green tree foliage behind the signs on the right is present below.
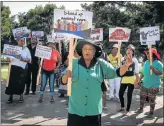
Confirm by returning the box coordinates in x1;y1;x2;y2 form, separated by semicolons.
81;1;164;59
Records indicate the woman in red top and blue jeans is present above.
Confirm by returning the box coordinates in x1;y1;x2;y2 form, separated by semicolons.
38;40;61;103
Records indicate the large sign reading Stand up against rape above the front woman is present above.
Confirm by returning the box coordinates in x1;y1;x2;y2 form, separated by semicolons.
54;9;93;39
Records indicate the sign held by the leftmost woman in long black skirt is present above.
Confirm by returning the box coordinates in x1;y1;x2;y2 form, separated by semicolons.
3;44;22;59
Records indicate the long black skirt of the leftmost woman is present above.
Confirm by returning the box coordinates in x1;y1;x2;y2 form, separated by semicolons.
5;65;26;95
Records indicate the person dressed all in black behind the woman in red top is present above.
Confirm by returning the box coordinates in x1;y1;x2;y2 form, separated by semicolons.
25;37;39;95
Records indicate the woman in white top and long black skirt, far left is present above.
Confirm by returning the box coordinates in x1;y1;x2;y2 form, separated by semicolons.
5;38;31;103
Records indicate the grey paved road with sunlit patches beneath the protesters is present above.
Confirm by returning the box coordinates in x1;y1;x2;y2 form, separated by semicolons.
1;84;163;126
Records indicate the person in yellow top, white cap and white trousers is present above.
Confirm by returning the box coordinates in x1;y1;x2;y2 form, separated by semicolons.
108;44;122;100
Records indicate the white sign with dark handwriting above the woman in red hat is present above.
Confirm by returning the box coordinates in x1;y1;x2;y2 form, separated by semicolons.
140;26;160;42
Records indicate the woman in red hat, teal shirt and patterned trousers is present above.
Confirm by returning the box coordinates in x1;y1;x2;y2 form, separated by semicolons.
137;48;163;118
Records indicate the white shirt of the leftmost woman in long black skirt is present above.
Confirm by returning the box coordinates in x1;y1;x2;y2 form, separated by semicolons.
11;47;31;69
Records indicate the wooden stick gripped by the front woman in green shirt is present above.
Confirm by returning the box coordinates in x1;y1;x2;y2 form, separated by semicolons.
67;38;74;96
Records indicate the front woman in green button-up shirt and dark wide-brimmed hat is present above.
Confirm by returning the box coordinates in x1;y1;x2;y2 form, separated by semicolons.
61;40;136;126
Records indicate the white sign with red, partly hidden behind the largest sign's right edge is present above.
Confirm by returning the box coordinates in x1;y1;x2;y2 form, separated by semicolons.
89;28;103;42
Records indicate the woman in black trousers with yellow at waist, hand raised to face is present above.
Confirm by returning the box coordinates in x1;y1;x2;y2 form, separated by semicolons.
118;44;139;115
